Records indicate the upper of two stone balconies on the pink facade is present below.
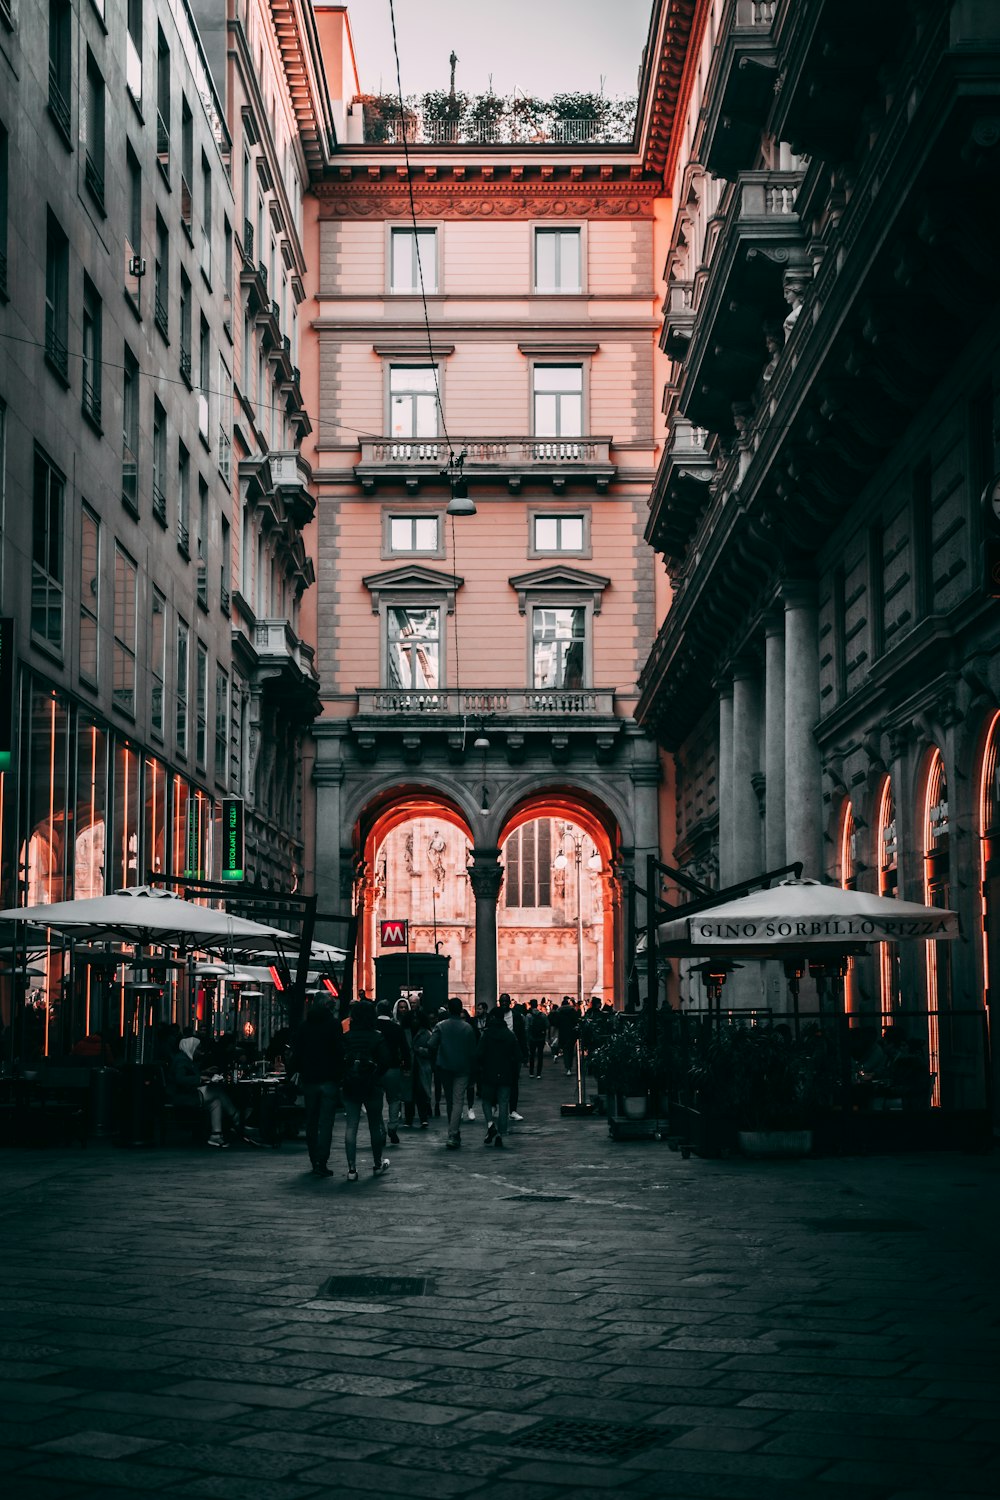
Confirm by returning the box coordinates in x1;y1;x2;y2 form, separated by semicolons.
354;437;616;495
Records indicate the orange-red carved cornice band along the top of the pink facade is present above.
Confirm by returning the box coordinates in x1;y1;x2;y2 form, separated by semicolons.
313;180;660;219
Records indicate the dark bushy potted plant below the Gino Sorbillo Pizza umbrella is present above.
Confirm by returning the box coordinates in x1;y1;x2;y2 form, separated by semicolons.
691;1025;814;1157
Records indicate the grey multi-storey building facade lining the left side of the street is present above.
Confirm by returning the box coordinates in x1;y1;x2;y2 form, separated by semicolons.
0;0;333;1050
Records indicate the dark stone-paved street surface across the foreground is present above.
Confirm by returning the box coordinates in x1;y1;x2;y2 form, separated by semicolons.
0;1074;1000;1500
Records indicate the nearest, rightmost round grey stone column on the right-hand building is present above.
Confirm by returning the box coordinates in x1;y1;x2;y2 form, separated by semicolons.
783;582;823;881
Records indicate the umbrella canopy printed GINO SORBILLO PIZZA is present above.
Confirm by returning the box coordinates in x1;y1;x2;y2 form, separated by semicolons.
658;881;960;959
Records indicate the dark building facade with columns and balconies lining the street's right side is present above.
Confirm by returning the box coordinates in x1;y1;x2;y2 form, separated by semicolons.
637;0;1000;1103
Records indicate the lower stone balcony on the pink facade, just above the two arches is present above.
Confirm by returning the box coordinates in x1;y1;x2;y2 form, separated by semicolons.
351;687;624;765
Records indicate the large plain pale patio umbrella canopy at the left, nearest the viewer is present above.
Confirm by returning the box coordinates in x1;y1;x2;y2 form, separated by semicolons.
0;885;295;950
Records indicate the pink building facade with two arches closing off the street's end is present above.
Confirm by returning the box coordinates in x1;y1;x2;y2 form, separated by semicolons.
306;8;660;1001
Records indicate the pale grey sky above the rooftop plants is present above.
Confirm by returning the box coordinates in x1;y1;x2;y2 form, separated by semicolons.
348;0;651;99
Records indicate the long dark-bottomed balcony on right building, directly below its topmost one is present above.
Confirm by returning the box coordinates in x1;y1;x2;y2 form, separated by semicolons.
679;170;805;434
